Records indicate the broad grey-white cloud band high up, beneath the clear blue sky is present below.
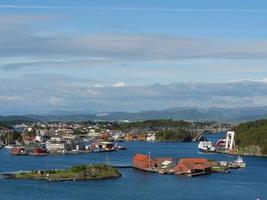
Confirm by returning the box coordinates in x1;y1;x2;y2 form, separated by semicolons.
0;28;267;61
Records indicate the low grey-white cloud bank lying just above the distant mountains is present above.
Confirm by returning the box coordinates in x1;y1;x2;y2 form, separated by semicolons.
0;79;267;113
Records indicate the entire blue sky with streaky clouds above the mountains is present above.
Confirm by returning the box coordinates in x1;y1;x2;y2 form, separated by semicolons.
0;0;267;115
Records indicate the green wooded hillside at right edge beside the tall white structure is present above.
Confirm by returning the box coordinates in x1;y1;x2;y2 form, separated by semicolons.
234;119;267;155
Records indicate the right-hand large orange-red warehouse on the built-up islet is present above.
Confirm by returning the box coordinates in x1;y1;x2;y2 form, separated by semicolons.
175;158;212;175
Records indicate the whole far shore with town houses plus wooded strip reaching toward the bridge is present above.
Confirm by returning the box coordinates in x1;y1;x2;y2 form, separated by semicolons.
0;120;233;156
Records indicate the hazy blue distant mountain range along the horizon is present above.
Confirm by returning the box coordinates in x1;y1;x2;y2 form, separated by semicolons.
0;106;267;122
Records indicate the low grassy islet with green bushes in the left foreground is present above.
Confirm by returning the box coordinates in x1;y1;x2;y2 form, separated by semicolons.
4;164;121;181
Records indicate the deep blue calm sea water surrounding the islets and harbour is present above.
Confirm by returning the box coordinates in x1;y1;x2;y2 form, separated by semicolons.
0;133;267;200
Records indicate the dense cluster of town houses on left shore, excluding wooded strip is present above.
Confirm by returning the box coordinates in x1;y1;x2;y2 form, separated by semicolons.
0;122;126;156
